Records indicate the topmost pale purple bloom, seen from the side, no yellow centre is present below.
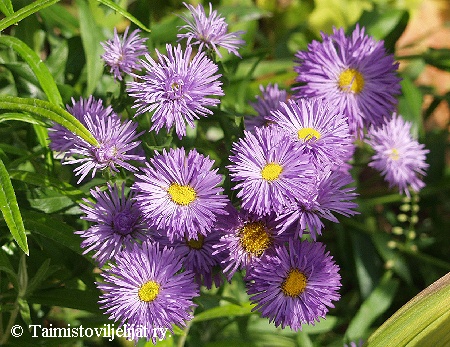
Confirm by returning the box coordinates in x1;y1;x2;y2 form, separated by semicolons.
177;3;245;58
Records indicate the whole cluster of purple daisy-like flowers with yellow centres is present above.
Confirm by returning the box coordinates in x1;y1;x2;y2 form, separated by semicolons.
46;4;427;342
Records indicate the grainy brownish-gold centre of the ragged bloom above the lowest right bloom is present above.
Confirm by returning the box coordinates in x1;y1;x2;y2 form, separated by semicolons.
238;222;272;257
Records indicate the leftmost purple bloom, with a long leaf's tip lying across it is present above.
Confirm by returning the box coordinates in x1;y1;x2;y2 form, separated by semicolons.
49;98;145;183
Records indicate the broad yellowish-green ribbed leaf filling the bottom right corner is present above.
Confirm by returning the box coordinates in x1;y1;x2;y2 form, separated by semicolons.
366;274;450;347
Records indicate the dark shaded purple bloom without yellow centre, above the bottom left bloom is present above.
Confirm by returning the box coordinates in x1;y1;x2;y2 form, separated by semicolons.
75;183;149;266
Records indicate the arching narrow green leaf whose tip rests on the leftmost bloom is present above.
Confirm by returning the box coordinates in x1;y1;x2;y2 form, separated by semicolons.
0;96;98;146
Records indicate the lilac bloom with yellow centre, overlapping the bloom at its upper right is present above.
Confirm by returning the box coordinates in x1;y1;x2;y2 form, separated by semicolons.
227;127;314;215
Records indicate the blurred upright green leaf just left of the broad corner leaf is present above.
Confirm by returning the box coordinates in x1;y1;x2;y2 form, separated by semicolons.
345;272;398;346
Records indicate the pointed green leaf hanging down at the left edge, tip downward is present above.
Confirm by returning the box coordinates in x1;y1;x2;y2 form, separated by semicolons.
0;160;28;255
